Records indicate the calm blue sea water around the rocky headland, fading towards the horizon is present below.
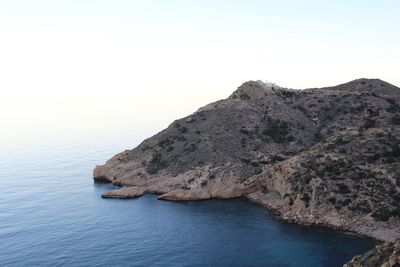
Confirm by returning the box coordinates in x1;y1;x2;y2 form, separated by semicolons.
0;104;375;267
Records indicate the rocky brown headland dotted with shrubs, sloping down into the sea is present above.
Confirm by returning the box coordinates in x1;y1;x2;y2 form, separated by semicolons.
94;79;400;264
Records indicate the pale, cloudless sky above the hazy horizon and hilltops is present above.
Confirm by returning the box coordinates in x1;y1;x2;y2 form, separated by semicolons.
0;0;400;103
